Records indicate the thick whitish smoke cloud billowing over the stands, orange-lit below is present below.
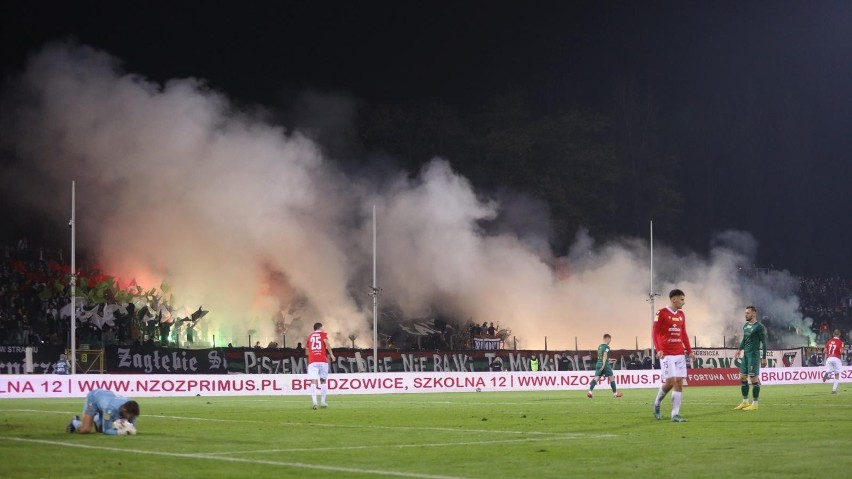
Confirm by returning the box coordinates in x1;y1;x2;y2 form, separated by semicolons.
3;44;802;349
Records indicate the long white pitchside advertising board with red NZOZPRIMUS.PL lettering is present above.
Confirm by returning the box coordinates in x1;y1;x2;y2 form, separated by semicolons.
0;366;852;398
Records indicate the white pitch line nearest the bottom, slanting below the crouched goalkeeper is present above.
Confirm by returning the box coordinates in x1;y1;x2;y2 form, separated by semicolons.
0;436;472;479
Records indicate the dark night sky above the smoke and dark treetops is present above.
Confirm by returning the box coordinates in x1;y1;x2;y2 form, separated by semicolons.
0;1;852;277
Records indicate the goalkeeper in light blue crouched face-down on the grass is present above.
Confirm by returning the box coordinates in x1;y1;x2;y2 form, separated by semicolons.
65;389;139;436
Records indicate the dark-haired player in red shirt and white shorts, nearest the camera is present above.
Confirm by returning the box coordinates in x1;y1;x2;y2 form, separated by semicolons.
653;289;695;422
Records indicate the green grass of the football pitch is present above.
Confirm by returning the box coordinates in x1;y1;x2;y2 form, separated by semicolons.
0;384;852;479
